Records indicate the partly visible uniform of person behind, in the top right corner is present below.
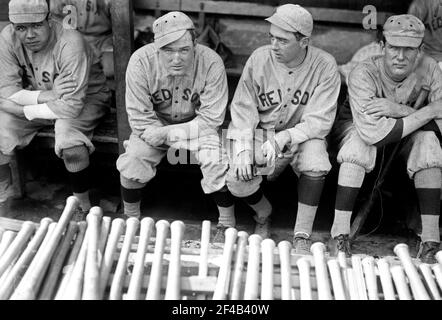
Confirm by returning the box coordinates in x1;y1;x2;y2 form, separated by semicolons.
408;0;442;61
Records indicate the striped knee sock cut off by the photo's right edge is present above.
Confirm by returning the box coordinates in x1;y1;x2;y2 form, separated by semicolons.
414;168;441;242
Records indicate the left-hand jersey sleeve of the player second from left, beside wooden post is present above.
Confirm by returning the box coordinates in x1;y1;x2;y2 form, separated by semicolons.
126;56;163;134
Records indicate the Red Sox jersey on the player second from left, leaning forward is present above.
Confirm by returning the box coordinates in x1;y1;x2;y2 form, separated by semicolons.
126;43;228;134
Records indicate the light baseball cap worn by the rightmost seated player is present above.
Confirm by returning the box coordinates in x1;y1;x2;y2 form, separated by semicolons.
384;14;425;48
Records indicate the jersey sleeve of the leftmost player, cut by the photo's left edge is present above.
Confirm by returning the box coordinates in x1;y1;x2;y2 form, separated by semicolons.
0;34;24;99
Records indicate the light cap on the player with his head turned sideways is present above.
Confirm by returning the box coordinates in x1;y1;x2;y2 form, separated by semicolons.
265;3;313;37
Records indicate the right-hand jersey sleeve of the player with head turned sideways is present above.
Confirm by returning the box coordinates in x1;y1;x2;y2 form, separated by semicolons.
288;59;341;144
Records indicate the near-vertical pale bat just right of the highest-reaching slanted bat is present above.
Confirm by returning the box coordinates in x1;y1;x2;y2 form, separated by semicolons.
82;207;103;300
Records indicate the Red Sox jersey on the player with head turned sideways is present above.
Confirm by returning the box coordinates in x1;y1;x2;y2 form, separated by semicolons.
227;45;341;153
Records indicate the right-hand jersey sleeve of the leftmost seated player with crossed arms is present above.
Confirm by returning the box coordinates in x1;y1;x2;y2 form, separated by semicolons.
47;36;92;119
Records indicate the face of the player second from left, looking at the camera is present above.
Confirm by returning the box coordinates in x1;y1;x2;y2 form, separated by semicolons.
159;32;195;76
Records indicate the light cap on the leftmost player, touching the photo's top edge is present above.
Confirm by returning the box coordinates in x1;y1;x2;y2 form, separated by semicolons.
9;0;49;23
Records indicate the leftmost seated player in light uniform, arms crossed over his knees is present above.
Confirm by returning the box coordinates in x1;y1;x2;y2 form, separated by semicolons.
0;0;110;218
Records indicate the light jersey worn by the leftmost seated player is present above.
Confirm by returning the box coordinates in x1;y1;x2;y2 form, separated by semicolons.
0;20;108;118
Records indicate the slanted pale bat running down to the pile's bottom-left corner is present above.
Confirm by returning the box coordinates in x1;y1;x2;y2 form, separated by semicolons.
0;218;53;300
